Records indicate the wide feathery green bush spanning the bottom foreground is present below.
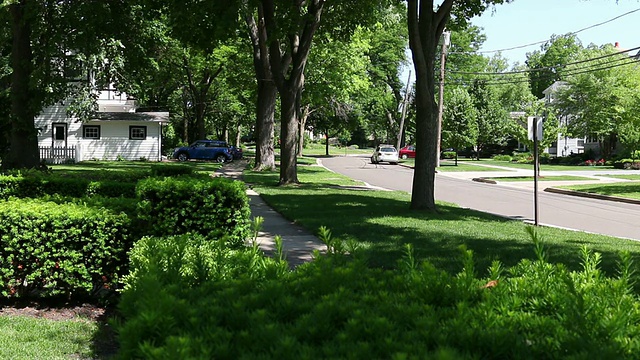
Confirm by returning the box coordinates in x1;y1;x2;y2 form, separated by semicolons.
118;229;640;359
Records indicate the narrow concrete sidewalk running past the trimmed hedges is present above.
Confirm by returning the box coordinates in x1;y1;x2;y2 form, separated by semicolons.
216;160;327;268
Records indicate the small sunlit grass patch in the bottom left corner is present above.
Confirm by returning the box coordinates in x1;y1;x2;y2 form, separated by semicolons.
0;316;98;359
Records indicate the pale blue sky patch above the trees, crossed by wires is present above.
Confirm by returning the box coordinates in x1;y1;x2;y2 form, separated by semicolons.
472;0;640;64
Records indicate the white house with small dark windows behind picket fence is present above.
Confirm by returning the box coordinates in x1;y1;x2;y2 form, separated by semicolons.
35;83;169;163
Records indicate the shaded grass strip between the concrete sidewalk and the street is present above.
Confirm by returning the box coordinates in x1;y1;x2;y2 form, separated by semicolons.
244;167;640;275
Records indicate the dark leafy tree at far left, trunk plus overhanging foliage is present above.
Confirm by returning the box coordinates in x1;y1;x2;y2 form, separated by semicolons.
0;0;132;169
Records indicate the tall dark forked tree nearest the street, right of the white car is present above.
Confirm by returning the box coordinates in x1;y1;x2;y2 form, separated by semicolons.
408;0;510;211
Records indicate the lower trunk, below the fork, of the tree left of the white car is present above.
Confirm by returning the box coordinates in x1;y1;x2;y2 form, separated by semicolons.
279;84;299;185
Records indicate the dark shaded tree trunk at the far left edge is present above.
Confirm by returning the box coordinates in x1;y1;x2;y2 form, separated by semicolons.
2;0;40;169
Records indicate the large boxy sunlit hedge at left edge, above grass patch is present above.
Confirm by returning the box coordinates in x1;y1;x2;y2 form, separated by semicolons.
0;199;132;297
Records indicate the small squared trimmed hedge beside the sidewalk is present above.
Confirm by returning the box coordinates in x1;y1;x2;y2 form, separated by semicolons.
137;177;251;246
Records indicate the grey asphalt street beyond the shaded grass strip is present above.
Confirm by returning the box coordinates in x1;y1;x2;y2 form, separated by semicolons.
322;156;640;240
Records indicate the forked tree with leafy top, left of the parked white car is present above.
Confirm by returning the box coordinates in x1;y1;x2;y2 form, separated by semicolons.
243;0;386;185
